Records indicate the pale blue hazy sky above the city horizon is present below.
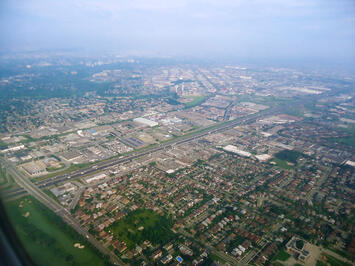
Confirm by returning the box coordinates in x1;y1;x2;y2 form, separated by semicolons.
0;0;355;59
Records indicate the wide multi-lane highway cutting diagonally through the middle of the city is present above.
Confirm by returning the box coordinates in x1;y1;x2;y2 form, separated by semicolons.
3;104;281;199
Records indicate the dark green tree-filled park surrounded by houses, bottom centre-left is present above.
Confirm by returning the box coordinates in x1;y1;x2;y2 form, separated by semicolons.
108;209;173;249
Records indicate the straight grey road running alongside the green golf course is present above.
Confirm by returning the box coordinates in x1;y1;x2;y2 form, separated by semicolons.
5;160;125;265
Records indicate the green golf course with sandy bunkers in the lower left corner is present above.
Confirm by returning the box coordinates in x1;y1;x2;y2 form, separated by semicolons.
5;196;105;266
